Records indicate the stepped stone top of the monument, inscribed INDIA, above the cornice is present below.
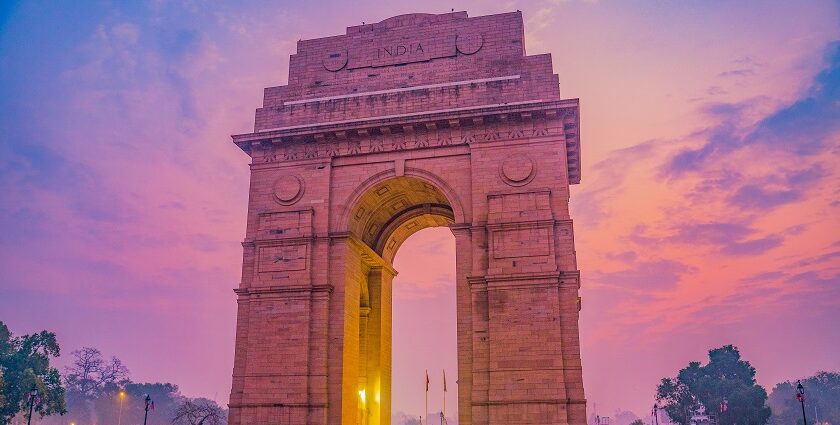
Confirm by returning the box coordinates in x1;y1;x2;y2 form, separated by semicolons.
244;12;572;133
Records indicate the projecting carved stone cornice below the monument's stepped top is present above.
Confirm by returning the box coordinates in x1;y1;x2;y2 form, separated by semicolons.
233;99;580;183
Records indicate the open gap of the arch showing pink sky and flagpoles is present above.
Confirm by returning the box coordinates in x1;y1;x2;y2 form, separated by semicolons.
392;228;459;424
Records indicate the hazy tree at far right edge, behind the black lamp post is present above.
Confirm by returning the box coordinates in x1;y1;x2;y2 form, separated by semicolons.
767;372;840;425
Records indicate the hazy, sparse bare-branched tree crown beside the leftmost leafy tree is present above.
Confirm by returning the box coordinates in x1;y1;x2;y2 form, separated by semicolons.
64;347;129;399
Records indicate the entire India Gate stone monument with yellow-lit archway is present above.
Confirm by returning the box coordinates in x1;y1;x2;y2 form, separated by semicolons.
230;12;586;425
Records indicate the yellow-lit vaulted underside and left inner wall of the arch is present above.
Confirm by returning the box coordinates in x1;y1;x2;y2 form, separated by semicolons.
343;176;456;425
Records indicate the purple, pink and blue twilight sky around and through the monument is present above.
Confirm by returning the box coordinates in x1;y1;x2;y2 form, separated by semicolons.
0;0;840;415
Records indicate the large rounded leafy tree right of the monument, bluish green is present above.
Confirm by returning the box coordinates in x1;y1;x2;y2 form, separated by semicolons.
656;345;770;425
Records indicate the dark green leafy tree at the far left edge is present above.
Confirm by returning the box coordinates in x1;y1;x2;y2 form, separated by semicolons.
0;321;66;423
